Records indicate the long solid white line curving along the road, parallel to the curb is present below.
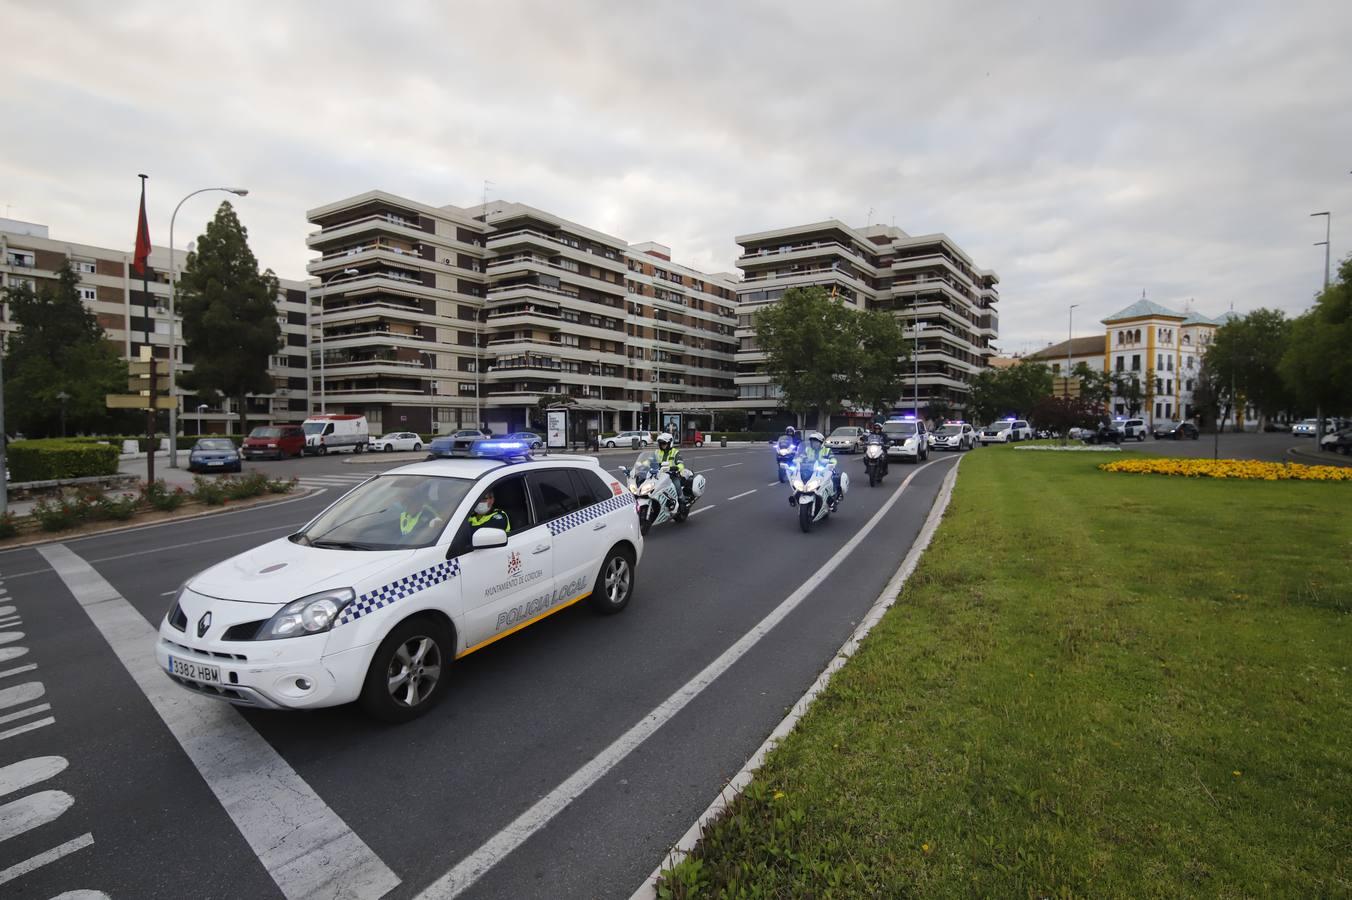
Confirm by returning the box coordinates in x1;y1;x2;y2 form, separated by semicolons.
416;462;951;900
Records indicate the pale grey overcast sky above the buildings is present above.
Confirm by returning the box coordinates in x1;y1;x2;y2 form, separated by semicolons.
0;0;1352;351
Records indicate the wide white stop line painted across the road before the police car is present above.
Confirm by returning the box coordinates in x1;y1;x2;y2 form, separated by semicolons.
37;543;399;900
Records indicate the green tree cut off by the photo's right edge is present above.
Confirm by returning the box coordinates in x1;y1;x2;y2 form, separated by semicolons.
1278;257;1352;415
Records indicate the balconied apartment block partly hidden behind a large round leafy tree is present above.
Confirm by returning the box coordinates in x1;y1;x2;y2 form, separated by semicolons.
735;219;999;426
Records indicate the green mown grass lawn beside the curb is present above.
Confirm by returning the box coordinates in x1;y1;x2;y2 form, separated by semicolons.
662;447;1352;899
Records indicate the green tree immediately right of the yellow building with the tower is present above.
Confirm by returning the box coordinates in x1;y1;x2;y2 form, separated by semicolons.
1206;309;1291;419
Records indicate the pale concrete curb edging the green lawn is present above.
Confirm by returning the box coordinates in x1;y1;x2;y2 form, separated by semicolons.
630;457;963;900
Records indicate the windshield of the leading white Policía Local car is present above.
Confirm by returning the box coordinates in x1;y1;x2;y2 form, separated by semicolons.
300;474;475;550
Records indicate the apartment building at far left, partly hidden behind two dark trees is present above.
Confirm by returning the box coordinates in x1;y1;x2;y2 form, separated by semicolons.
0;213;310;434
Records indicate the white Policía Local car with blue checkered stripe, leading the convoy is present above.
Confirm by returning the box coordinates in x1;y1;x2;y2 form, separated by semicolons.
155;442;644;722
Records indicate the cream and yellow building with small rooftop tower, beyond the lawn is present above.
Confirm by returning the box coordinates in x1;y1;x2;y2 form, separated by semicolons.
1102;297;1234;424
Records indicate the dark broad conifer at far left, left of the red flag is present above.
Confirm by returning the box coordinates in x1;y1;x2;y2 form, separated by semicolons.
4;262;127;435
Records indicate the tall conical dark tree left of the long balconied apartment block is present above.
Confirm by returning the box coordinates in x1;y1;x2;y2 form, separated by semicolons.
178;201;281;434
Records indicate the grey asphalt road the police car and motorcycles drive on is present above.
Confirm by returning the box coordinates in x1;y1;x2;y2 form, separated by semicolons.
0;447;955;897
